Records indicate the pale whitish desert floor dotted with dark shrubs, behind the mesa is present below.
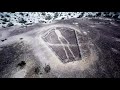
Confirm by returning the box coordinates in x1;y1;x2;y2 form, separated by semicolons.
0;12;120;28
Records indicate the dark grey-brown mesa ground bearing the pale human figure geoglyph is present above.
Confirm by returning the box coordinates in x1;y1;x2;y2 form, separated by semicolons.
0;18;120;78
